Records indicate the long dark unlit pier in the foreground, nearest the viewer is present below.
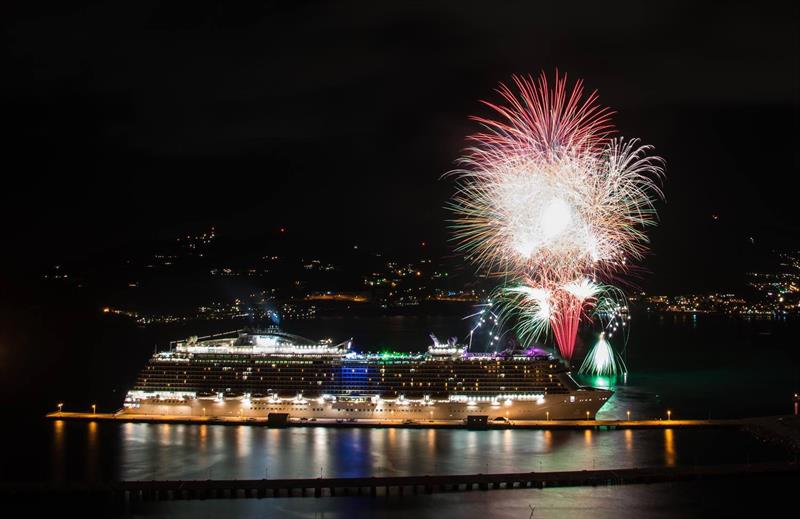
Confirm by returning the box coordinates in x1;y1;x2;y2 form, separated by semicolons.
0;462;800;504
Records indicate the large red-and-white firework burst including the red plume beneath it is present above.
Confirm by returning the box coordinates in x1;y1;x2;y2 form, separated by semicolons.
450;72;663;360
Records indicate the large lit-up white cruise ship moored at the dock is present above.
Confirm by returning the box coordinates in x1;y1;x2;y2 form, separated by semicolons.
120;328;612;423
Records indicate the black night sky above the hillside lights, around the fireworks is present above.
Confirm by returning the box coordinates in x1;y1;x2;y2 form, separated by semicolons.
0;1;800;289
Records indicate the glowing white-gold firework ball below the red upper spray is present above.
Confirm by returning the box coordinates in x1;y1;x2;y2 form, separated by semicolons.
450;139;662;276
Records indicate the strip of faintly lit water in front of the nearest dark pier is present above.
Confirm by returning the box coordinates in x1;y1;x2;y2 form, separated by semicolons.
121;479;792;519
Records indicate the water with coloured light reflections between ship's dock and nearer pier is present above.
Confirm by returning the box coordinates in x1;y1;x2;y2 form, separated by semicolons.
40;421;785;480
